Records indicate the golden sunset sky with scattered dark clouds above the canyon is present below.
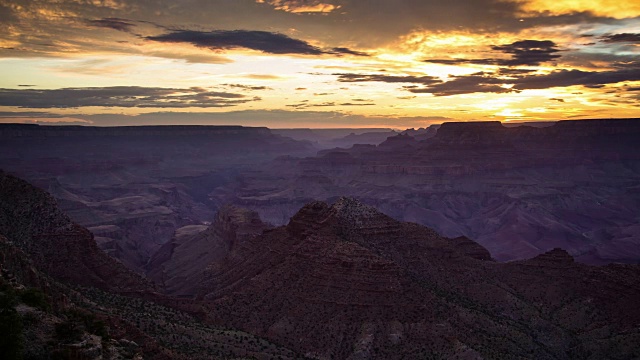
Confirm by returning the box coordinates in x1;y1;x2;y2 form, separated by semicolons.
0;0;640;129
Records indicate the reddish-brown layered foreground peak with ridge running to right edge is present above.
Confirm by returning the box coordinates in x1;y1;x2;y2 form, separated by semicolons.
200;198;640;359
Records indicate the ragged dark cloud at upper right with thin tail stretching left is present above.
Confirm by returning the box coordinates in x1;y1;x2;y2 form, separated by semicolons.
425;40;560;66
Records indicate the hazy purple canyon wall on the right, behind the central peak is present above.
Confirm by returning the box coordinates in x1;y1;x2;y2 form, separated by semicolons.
210;119;640;264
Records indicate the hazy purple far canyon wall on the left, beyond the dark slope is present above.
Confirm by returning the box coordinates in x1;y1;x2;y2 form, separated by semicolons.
0;124;315;274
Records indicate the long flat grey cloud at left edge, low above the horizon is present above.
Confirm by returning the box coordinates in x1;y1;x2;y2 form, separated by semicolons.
0;86;255;108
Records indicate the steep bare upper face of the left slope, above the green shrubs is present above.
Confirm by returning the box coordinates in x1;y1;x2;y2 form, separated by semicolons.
0;172;152;292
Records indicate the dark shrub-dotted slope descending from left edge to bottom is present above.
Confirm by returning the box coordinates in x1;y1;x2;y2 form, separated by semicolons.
0;172;301;360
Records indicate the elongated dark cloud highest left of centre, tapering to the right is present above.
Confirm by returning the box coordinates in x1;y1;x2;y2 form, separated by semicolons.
145;30;368;56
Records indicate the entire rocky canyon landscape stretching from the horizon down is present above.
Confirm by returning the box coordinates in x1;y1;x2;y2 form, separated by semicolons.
0;119;640;359
